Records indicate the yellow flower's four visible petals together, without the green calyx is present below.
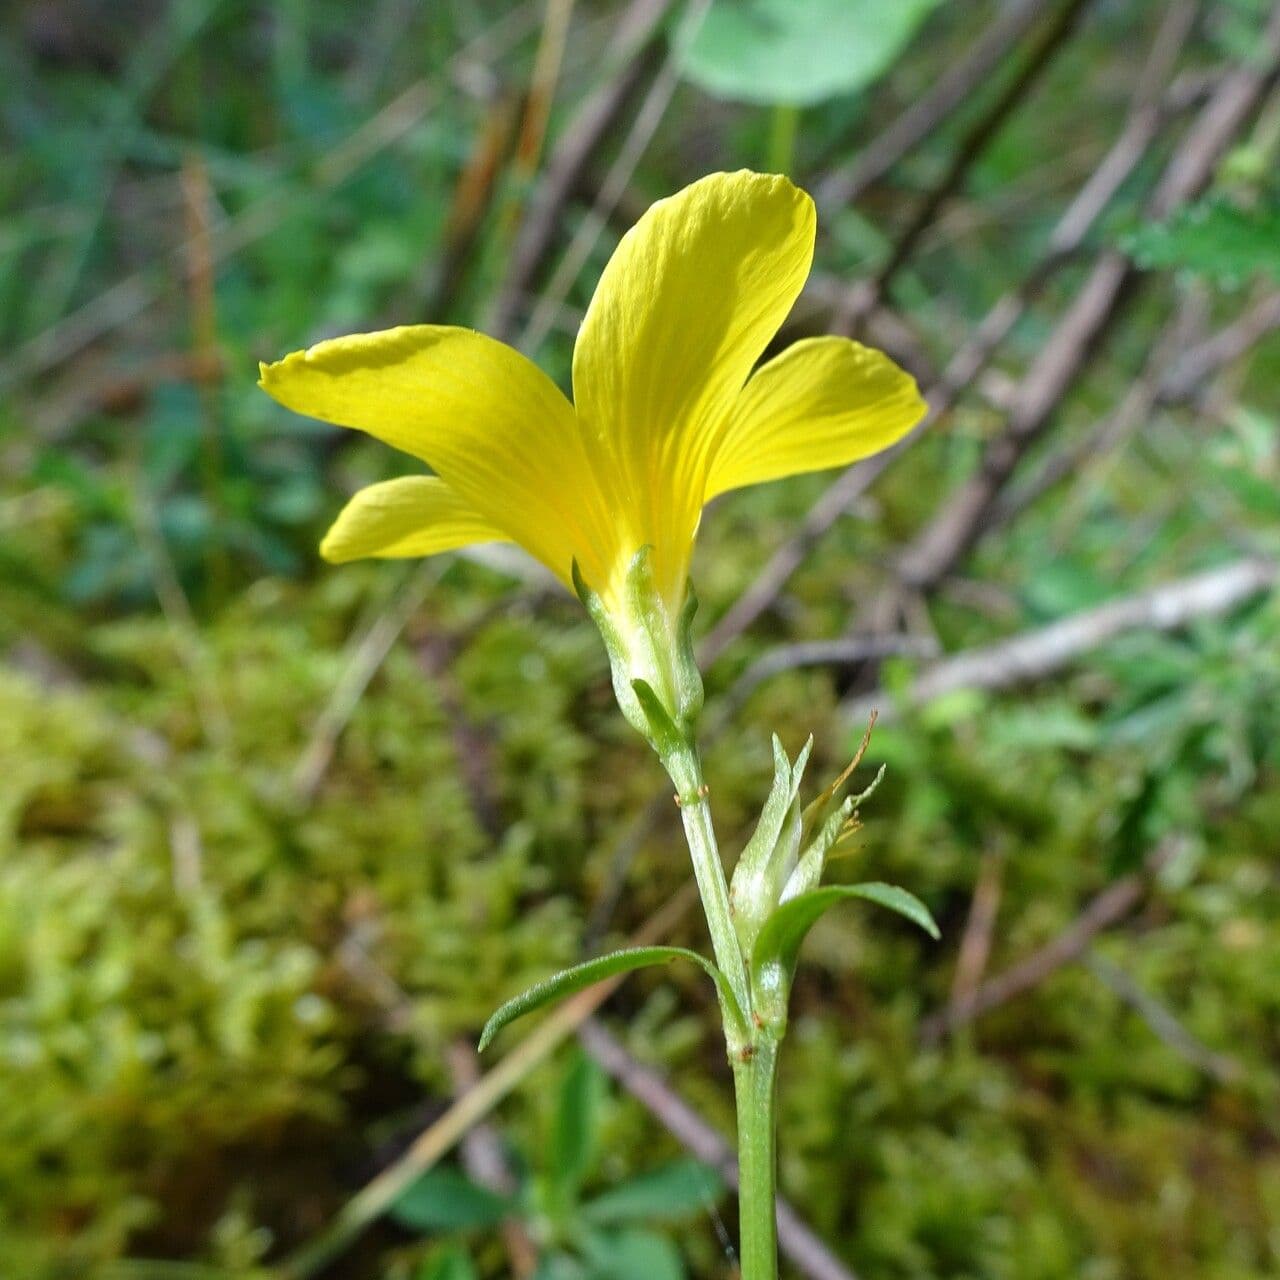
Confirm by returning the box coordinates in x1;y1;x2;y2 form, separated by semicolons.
261;172;924;618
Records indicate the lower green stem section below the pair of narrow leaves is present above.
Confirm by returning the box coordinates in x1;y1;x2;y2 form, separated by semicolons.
733;1036;778;1280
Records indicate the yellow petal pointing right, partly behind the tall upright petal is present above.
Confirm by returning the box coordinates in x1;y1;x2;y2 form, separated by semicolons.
707;338;927;499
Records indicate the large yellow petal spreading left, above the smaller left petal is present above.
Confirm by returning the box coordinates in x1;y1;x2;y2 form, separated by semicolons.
262;325;611;584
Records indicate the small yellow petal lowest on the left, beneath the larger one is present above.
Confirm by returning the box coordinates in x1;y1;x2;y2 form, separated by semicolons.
320;476;507;564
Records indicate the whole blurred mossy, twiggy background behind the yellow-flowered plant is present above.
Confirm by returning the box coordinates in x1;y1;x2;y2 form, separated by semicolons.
0;0;1280;1280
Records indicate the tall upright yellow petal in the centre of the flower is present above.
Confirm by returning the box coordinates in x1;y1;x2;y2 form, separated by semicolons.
573;172;814;596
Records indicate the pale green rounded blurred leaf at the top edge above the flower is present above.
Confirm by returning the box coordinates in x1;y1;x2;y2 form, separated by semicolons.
684;0;938;106
